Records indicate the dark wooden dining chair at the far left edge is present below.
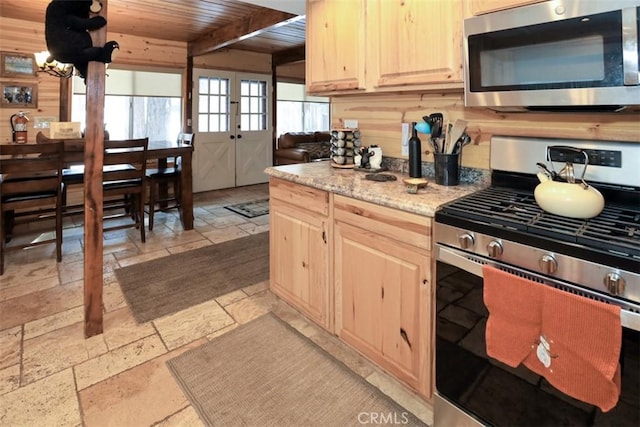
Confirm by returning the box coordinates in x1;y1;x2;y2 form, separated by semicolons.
0;142;64;275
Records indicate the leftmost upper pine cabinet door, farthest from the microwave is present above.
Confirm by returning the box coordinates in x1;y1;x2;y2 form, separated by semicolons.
306;0;365;93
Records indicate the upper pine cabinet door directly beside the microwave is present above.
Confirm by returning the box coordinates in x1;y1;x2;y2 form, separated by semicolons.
367;0;463;88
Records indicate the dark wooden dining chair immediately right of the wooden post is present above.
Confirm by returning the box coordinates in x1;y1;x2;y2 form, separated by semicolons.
102;138;149;243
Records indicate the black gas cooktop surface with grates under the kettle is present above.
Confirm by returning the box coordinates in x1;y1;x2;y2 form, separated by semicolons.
435;187;640;271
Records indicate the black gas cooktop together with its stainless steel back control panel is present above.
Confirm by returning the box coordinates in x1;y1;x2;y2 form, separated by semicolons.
435;137;640;272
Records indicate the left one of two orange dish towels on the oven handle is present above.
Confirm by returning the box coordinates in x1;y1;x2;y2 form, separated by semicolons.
482;265;544;368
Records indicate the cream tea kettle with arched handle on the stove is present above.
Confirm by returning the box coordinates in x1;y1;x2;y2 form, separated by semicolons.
534;146;604;219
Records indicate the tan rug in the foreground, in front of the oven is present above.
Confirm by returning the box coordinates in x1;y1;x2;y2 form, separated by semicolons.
167;313;425;427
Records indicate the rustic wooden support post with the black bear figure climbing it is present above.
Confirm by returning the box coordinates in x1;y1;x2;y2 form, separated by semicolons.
84;0;108;338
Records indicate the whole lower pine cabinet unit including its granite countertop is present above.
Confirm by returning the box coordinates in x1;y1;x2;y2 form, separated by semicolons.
265;162;488;402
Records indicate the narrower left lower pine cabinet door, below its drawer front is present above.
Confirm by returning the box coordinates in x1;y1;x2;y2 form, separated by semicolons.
269;197;331;330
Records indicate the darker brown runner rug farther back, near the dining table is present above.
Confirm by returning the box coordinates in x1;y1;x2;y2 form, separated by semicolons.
115;232;269;323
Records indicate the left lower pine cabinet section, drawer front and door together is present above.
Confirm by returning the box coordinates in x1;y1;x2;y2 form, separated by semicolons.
269;178;333;331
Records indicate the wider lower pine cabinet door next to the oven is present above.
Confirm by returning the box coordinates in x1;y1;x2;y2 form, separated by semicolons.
334;222;432;399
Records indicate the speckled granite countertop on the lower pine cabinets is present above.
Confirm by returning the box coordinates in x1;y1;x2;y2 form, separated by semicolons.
265;161;489;217
